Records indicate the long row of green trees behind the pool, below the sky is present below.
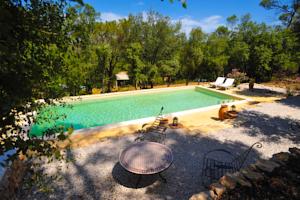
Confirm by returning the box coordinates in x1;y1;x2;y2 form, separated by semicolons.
60;11;299;90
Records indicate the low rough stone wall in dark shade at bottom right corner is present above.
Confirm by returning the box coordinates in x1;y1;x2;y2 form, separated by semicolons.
190;148;300;200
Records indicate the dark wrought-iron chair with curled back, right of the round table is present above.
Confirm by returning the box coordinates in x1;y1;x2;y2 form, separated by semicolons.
202;142;262;185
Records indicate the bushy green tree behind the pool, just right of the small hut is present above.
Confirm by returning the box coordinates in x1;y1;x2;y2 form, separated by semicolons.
121;11;182;88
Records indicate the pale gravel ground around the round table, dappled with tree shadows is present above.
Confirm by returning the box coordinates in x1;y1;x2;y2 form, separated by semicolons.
20;96;300;200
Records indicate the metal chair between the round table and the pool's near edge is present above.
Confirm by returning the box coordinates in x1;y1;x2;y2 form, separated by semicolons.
134;107;167;143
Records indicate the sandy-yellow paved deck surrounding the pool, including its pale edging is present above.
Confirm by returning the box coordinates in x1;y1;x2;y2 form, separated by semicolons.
60;85;283;147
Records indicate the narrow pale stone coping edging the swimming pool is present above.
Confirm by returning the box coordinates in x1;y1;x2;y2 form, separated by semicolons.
69;85;251;136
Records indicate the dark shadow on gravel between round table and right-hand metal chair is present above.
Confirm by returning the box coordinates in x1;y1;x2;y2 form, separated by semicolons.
141;131;260;199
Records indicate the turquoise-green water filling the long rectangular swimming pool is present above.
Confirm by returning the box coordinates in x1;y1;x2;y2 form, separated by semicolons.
30;88;235;136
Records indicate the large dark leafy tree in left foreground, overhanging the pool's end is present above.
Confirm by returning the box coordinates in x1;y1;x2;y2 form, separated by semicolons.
0;0;83;167
